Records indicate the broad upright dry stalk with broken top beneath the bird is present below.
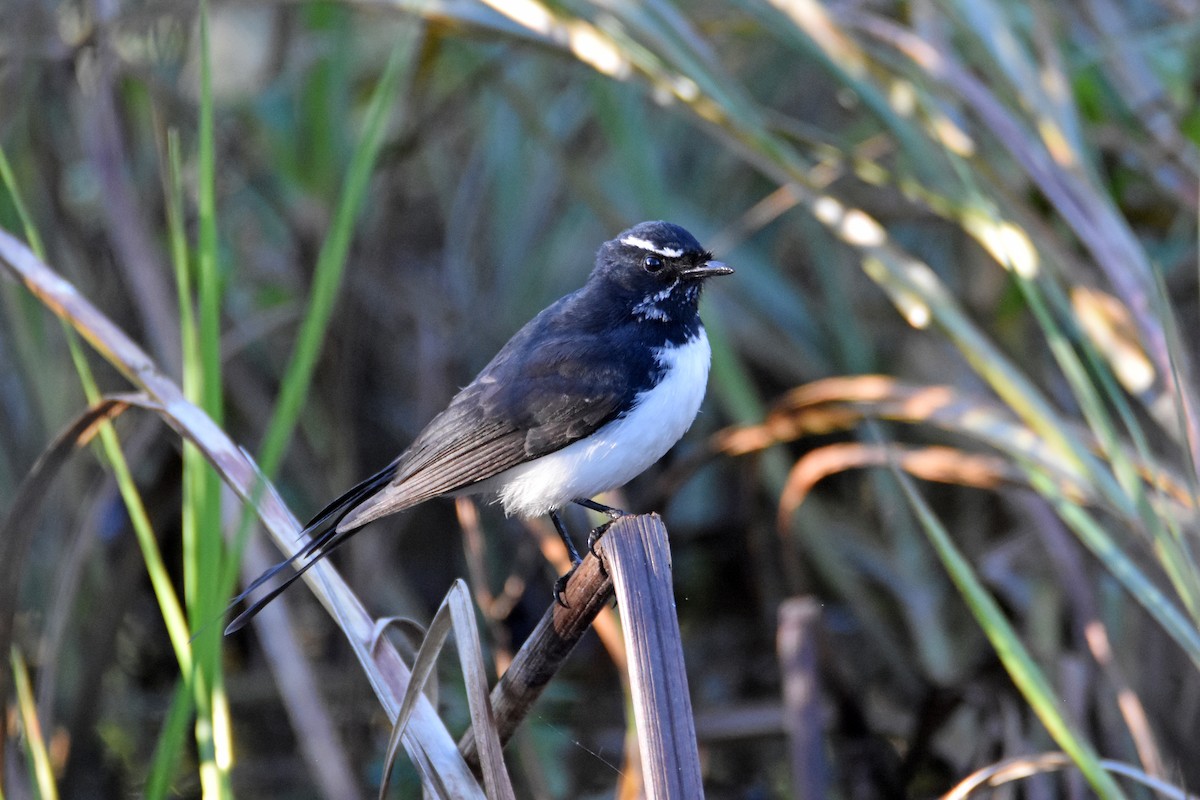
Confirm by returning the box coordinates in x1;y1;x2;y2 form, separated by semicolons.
598;515;704;800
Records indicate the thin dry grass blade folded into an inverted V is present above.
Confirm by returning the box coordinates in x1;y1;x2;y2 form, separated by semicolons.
379;578;515;800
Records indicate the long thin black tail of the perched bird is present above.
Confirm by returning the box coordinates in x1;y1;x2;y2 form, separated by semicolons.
224;462;405;636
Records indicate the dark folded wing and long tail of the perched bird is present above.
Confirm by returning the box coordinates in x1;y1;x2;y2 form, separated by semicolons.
226;311;660;633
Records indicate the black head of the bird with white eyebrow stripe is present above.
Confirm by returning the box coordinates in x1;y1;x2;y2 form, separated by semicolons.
592;222;733;323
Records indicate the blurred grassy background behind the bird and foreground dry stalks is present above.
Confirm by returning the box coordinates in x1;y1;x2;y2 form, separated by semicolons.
0;0;1200;799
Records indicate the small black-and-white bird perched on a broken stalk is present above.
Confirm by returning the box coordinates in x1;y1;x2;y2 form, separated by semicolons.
226;221;733;634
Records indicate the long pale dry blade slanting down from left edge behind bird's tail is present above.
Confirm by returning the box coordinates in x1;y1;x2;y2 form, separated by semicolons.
0;230;481;798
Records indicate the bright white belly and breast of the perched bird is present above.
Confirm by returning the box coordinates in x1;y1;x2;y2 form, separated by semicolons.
480;329;712;517
